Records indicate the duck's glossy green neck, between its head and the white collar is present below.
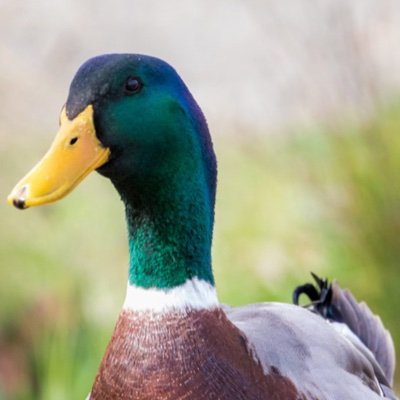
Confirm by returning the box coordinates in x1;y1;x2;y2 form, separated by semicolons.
118;164;214;290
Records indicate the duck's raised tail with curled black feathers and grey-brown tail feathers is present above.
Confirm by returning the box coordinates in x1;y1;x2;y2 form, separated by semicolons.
293;274;395;385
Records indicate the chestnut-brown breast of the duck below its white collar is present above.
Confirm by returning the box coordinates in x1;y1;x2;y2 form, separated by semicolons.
90;309;305;400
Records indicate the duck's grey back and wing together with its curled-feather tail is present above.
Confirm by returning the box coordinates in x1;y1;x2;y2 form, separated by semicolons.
225;277;397;400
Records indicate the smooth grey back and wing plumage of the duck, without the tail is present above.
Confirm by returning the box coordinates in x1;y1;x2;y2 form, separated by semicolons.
225;303;396;400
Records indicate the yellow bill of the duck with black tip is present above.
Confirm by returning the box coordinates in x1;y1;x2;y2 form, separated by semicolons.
7;105;110;209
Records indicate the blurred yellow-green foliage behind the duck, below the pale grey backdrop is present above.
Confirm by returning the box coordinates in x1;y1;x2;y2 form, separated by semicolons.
0;104;400;400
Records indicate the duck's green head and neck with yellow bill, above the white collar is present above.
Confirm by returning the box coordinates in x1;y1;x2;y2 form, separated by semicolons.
9;54;216;288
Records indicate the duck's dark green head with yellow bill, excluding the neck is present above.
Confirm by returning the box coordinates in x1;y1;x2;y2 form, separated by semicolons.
8;54;216;209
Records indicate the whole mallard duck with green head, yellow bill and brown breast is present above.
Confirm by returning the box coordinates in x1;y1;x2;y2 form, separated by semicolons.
8;54;396;400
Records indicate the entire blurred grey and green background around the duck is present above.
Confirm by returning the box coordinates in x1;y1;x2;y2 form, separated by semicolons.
0;0;400;400
